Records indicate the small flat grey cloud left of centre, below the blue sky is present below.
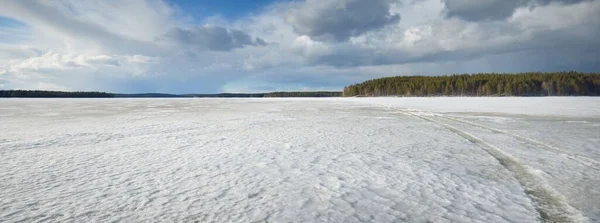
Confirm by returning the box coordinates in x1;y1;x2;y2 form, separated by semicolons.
166;26;266;51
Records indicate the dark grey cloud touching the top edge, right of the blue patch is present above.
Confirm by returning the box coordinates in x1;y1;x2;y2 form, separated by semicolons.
286;0;400;41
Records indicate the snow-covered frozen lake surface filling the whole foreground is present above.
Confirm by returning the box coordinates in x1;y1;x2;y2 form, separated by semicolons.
0;97;600;222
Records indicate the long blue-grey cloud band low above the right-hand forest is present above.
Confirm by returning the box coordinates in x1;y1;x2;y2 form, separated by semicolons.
307;20;600;71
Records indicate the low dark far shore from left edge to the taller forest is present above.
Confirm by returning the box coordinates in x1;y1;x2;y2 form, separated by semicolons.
0;90;342;98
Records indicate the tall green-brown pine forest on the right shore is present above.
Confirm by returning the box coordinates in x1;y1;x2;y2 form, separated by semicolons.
343;72;600;97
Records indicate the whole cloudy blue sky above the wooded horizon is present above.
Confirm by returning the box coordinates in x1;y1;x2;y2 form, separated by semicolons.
0;0;600;93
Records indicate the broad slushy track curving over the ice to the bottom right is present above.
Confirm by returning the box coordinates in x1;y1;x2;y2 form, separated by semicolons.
399;110;585;222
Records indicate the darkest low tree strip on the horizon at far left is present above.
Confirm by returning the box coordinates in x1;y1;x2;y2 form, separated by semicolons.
0;90;114;98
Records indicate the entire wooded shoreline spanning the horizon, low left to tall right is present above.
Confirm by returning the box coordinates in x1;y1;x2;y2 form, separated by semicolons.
0;72;600;98
